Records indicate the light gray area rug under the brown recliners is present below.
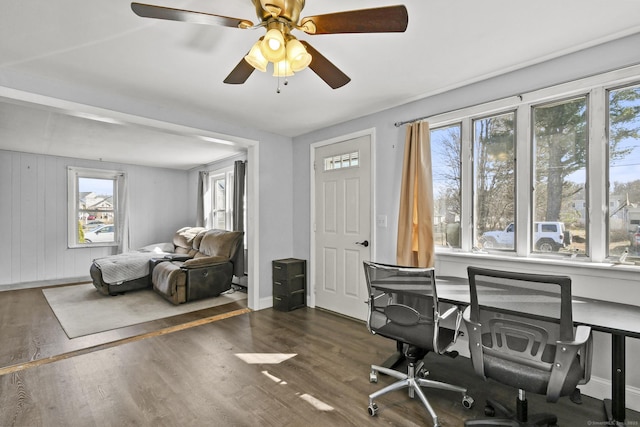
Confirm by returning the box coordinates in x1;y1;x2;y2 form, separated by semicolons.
42;283;247;338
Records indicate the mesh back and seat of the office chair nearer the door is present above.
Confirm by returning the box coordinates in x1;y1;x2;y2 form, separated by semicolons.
364;262;454;353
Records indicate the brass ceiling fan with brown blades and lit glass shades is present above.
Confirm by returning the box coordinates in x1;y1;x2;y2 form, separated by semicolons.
131;0;409;89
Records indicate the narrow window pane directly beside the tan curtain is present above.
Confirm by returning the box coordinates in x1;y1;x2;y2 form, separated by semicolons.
431;124;461;248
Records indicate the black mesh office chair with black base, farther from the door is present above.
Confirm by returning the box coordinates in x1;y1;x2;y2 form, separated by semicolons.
463;267;592;427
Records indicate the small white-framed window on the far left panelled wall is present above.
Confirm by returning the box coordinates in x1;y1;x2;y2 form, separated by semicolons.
68;167;124;248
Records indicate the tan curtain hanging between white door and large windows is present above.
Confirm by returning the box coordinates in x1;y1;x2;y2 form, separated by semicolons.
396;122;435;267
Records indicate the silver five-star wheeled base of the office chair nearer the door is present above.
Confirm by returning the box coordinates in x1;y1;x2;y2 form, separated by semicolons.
368;363;473;427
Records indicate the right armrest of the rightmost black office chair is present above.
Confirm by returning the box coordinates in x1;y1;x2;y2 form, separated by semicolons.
547;325;591;402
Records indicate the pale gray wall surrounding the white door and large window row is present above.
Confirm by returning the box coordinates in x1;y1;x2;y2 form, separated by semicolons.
293;34;640;410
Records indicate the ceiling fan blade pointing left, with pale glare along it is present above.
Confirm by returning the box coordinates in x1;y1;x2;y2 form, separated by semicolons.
131;2;253;28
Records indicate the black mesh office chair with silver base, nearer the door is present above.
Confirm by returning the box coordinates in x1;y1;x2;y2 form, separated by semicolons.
364;261;473;426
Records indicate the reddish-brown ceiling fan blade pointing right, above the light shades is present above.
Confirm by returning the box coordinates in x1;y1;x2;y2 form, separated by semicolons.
300;5;409;34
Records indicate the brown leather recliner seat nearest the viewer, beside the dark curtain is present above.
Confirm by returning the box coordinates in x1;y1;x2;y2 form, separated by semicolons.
149;229;244;304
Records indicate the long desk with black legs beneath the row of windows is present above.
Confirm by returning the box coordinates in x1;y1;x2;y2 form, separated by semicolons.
436;276;640;423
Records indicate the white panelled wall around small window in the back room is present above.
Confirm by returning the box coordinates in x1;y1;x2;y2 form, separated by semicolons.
0;149;190;286
